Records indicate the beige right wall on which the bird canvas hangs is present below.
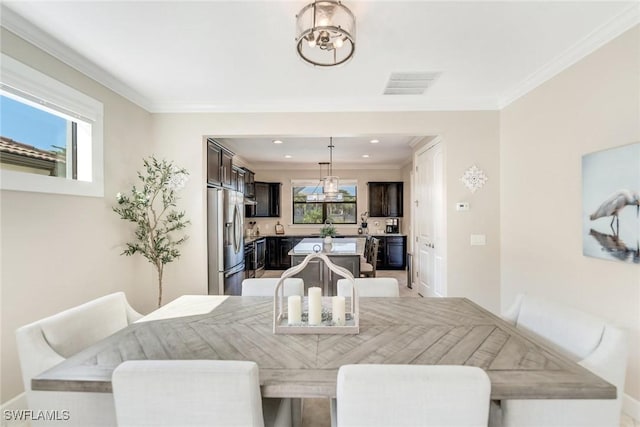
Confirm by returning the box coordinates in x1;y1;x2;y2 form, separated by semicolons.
500;27;640;399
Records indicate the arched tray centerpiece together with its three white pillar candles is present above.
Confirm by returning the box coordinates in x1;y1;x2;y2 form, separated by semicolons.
273;253;360;334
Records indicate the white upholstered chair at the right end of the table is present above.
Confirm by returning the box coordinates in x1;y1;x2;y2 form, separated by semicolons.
491;295;628;427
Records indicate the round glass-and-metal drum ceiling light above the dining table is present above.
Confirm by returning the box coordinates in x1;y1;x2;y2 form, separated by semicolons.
296;0;356;67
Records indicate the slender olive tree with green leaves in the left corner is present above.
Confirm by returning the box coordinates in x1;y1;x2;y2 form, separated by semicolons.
113;156;189;307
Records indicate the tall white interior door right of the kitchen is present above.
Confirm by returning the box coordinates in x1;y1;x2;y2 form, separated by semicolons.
414;143;447;297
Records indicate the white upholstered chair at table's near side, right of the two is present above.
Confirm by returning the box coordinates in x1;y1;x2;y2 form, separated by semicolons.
336;365;491;427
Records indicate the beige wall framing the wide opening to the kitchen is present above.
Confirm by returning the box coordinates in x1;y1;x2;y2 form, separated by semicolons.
153;111;500;311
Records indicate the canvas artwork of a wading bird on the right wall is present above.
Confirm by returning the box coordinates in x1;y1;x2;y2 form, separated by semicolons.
582;142;640;265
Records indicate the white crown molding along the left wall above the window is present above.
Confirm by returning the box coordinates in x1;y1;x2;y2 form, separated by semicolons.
0;5;151;111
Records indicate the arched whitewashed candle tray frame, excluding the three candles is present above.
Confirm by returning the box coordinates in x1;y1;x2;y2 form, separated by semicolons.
273;253;360;334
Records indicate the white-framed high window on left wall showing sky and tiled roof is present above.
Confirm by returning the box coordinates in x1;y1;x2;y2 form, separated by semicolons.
0;55;104;197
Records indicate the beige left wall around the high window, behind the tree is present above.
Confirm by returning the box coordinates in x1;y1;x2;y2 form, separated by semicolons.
0;29;156;402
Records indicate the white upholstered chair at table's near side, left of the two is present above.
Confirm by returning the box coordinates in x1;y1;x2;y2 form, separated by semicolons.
112;360;291;427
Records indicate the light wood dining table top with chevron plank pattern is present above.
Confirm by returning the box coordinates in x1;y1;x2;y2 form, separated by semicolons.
32;296;616;400
